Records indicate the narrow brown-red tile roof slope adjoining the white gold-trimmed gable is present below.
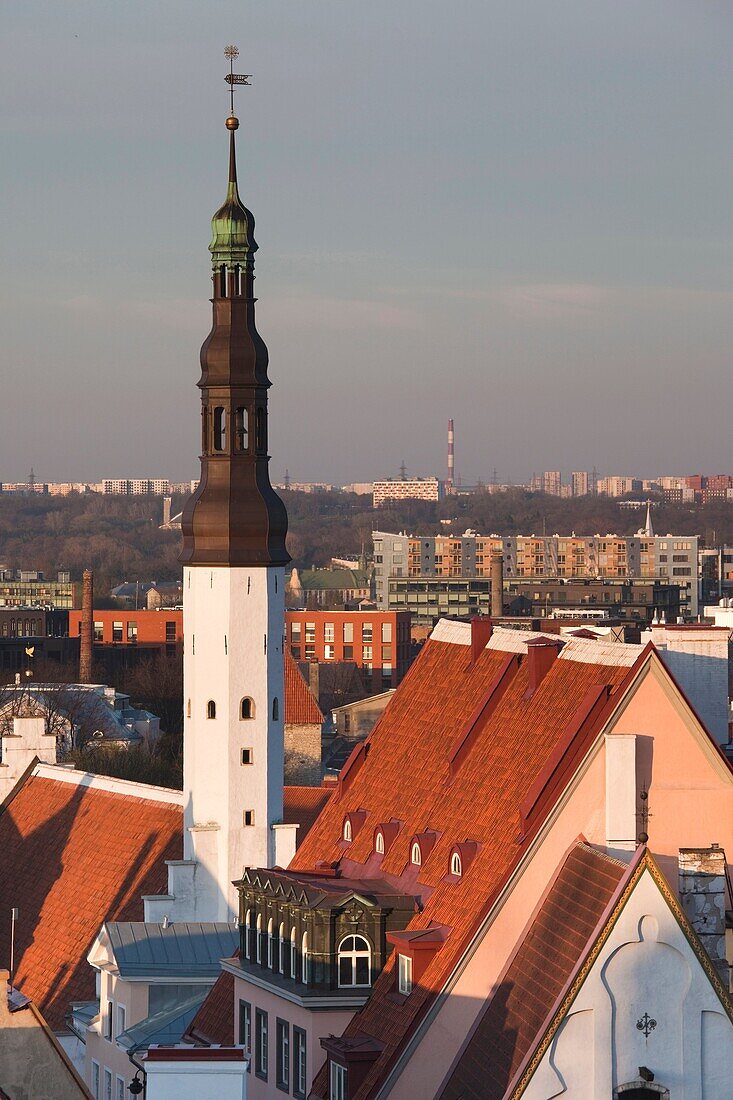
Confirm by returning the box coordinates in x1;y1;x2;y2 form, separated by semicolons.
440;844;627;1100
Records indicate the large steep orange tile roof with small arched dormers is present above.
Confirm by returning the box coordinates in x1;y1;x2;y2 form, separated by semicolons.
291;639;630;1100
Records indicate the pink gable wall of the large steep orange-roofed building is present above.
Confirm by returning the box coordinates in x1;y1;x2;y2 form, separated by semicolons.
381;656;733;1100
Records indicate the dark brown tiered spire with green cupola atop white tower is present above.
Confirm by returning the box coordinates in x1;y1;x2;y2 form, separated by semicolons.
180;54;289;565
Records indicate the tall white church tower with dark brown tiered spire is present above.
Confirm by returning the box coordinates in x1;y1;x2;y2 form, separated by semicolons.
176;66;294;921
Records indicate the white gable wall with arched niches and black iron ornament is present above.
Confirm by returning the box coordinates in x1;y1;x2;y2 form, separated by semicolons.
523;869;733;1100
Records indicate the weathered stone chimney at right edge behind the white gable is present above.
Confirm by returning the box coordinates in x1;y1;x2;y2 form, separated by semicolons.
679;844;730;990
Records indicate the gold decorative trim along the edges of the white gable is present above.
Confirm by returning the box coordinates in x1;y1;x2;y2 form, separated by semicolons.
506;849;733;1100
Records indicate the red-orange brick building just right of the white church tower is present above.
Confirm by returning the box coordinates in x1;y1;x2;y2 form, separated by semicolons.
285;611;412;692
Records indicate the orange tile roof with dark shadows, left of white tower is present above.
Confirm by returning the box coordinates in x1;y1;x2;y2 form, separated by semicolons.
0;774;183;1031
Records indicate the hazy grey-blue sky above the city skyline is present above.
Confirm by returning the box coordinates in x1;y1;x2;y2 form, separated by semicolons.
0;0;733;483
